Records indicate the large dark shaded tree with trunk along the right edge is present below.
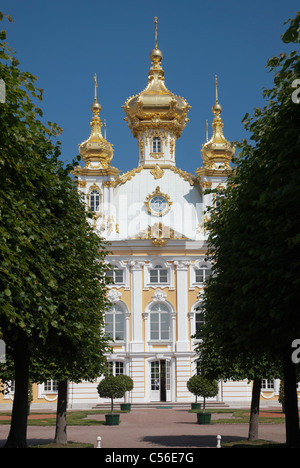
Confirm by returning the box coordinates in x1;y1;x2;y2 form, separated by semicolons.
204;13;300;445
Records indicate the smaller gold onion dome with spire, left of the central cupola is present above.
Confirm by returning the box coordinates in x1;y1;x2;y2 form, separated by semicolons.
79;75;114;169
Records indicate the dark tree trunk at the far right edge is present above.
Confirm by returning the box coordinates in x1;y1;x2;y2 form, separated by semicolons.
283;353;300;447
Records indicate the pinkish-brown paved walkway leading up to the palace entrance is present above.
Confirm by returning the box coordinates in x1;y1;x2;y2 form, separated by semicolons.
0;408;285;450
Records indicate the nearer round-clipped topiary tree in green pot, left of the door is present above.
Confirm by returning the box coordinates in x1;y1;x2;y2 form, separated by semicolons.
97;375;126;426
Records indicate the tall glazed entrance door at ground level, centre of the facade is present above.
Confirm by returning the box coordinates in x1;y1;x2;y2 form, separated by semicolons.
151;360;171;401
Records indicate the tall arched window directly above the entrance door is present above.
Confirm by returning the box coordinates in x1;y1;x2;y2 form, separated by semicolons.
150;303;170;341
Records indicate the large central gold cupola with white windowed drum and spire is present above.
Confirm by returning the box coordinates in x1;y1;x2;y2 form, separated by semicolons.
123;17;190;165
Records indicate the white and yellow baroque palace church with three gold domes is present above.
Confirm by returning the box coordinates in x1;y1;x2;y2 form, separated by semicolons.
0;18;290;408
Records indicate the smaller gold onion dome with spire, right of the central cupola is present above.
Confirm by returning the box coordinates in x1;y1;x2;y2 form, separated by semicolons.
201;77;235;169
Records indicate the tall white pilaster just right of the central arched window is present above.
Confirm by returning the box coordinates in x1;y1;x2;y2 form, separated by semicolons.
174;260;190;351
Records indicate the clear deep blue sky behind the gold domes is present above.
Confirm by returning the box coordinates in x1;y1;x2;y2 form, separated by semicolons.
0;0;299;173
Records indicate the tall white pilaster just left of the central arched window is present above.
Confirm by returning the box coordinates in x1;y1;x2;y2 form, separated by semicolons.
130;261;144;352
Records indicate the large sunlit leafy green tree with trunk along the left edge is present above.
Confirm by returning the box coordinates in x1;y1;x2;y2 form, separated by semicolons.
0;13;110;447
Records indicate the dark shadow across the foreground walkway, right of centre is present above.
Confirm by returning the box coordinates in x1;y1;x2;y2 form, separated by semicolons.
142;435;243;448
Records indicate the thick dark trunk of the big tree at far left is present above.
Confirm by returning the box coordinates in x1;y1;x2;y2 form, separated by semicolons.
5;338;29;448
